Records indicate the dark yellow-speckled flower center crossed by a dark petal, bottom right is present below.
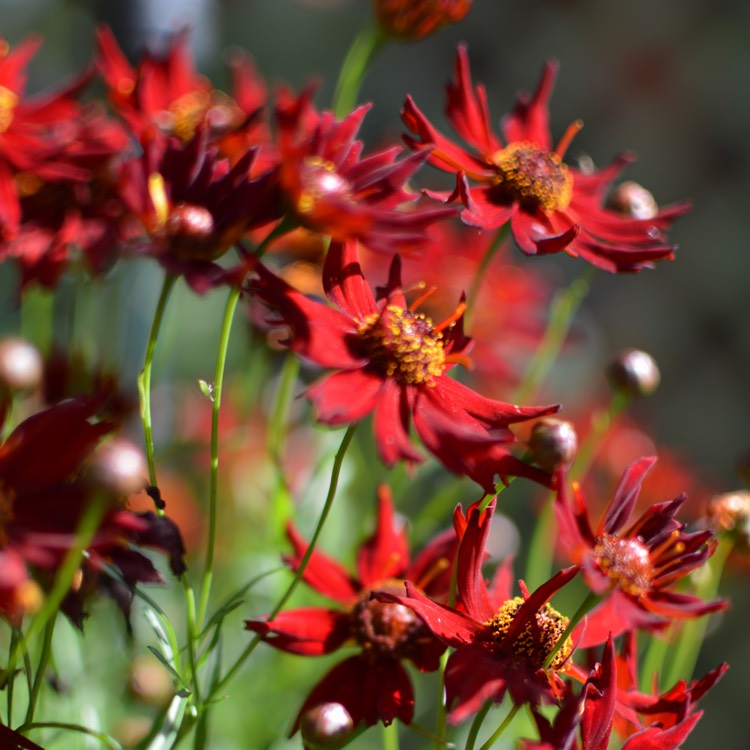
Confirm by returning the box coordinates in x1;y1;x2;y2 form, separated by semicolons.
485;596;573;671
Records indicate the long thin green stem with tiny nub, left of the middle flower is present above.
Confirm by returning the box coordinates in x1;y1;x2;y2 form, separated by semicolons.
196;286;240;632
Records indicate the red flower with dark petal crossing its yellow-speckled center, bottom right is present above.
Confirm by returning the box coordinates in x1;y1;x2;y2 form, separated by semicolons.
378;501;578;723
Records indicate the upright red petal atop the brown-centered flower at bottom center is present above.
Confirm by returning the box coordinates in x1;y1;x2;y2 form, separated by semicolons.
357;484;409;588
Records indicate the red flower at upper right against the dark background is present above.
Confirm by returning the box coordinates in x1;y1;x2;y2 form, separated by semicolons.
403;47;689;271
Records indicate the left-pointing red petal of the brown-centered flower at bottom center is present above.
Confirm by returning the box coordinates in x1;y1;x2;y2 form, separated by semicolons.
245;607;351;656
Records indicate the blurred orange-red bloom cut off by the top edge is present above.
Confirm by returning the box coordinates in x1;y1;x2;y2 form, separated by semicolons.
375;0;472;39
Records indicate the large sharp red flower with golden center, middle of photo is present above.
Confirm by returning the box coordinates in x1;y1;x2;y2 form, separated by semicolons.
250;242;558;492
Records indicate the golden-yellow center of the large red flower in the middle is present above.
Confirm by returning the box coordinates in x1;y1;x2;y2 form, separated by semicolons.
359;305;445;385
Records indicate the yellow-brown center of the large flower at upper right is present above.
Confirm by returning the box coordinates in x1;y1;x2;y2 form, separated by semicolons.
492;141;573;214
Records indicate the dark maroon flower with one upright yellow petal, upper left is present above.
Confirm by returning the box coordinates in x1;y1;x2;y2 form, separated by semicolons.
121;130;281;293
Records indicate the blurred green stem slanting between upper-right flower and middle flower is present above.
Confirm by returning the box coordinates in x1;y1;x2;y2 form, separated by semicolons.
512;266;594;404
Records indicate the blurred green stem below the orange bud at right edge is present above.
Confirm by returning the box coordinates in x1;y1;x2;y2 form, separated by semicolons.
664;536;734;688
